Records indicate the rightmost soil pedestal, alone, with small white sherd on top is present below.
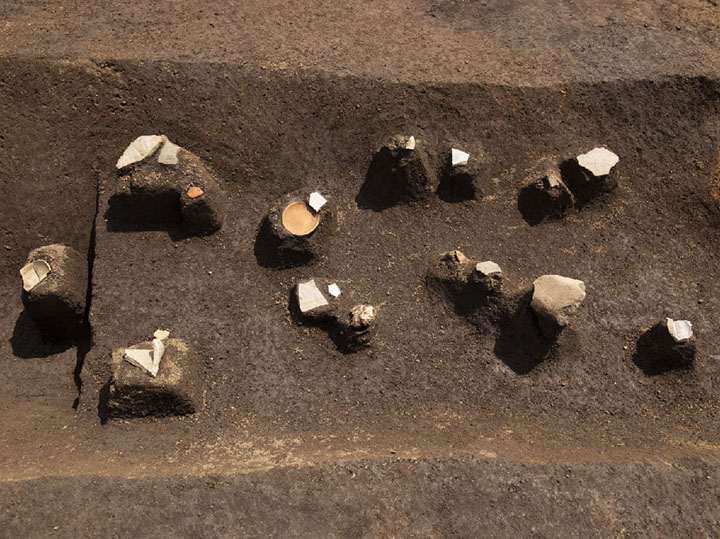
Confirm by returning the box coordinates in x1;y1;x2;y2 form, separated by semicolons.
635;318;696;374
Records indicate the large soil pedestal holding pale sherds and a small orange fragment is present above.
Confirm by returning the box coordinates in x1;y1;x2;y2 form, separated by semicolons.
110;135;225;236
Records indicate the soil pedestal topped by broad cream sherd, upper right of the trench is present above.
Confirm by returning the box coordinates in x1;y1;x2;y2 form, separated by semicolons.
560;147;620;207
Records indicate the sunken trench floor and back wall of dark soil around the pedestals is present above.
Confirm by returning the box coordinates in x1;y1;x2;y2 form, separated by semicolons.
0;54;720;532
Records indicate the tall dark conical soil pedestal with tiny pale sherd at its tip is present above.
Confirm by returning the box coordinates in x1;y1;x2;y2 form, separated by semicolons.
357;135;437;210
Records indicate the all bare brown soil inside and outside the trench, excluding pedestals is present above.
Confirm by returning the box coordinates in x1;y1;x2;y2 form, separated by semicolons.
0;0;720;537
